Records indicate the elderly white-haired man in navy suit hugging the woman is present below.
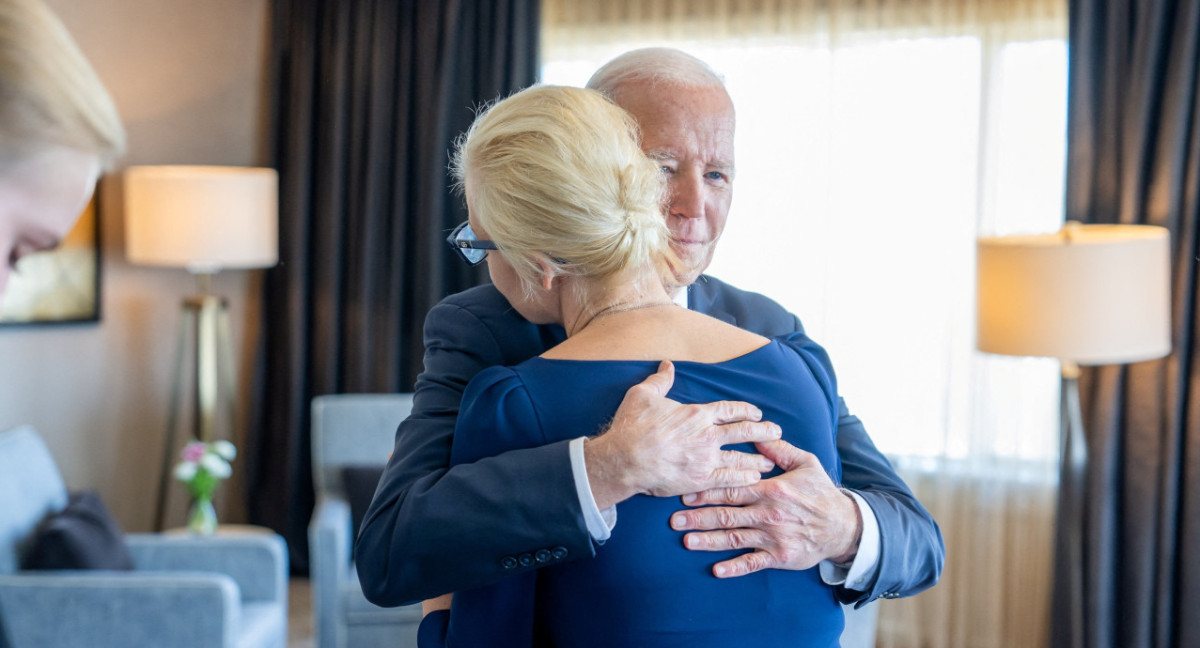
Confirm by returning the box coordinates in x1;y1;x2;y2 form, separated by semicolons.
356;49;944;612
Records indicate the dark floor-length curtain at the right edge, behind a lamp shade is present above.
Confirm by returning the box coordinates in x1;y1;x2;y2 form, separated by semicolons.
1051;0;1200;648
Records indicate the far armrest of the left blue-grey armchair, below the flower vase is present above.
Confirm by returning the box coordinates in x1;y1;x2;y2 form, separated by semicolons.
125;532;288;604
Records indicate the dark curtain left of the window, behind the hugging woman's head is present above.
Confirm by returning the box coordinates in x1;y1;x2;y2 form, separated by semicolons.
248;0;539;572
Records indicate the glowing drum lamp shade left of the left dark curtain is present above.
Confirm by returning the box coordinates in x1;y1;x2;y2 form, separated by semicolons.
125;166;278;272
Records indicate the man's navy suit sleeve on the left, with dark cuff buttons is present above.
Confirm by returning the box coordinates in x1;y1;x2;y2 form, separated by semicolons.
355;301;595;606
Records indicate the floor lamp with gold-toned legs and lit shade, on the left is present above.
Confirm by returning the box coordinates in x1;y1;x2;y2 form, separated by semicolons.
125;166;278;530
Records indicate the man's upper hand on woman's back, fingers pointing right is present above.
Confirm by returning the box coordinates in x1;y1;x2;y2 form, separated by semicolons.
583;361;781;510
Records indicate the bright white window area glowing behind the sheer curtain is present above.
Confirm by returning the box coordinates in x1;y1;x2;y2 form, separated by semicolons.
542;24;1067;466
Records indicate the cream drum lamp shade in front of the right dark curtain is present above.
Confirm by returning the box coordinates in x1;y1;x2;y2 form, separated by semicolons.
976;223;1171;365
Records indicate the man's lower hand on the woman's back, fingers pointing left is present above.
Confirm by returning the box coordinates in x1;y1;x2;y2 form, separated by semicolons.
671;440;863;577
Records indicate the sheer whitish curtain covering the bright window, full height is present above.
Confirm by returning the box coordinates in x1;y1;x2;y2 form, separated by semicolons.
541;0;1067;648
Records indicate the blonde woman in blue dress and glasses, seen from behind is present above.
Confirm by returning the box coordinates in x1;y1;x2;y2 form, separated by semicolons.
421;86;842;647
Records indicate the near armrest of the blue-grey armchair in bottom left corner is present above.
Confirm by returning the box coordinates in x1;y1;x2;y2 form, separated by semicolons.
0;571;240;648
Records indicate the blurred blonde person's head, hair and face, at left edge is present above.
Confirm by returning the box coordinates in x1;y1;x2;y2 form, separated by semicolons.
0;0;125;295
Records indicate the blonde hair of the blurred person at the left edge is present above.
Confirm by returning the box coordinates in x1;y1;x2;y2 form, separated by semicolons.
0;0;125;168
